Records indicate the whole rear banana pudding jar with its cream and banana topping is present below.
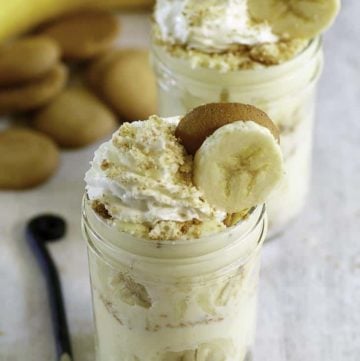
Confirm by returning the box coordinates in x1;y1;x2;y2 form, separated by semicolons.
152;0;340;235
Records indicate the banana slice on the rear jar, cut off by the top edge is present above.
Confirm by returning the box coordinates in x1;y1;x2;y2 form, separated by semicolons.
248;0;340;38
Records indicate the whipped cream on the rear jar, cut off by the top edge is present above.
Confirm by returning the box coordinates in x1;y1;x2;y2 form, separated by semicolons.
154;0;278;52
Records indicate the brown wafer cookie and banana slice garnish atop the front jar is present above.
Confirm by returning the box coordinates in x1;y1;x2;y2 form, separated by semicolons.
176;103;283;213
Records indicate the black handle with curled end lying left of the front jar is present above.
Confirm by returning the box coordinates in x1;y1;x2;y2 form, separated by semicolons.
26;214;72;361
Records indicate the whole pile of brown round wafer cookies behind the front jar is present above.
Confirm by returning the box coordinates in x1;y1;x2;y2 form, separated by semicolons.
0;11;156;189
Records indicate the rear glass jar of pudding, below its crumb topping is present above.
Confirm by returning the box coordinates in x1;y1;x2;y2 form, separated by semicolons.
152;38;323;235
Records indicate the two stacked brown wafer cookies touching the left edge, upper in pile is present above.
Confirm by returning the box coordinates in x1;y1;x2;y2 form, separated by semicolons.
0;36;68;114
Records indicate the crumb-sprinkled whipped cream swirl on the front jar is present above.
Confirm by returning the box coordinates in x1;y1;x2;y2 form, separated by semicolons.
85;116;227;239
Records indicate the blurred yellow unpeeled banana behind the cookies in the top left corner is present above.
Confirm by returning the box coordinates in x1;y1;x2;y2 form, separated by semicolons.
0;0;154;43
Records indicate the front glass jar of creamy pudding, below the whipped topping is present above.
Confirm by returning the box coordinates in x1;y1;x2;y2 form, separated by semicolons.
82;200;267;361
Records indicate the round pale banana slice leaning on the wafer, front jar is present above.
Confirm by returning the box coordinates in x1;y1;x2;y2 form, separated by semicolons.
193;121;283;213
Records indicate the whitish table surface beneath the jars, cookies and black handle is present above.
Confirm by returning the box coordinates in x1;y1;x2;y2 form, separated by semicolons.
0;0;360;361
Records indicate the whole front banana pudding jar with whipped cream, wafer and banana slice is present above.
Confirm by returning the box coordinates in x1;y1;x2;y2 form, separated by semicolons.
82;103;283;361
